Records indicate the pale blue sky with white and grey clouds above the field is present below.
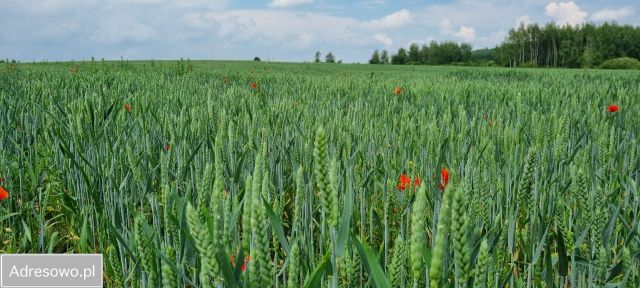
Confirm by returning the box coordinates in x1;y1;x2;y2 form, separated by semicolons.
0;0;640;63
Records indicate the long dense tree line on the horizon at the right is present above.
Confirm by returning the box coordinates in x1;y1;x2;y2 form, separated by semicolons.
369;23;640;68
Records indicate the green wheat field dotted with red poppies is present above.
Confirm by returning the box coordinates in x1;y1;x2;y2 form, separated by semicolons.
0;61;640;288
